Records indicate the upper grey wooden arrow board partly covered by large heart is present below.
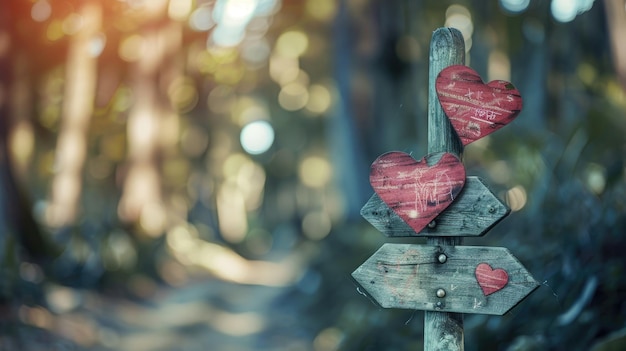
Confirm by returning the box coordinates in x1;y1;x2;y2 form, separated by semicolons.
361;177;511;237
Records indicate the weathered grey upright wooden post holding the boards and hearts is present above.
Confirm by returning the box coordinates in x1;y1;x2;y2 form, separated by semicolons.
424;28;465;351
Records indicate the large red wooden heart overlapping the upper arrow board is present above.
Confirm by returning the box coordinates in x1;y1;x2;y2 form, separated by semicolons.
370;151;465;233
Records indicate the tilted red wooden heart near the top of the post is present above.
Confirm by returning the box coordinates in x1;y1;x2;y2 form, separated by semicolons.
435;65;522;145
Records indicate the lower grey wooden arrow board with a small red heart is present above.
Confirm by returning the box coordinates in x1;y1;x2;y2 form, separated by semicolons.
352;244;539;315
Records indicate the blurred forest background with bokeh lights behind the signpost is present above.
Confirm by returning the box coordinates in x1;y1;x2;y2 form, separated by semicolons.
0;0;626;351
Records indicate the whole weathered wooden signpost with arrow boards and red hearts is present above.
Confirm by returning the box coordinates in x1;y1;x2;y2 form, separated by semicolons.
352;28;539;351
